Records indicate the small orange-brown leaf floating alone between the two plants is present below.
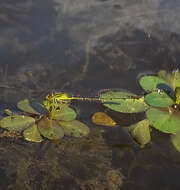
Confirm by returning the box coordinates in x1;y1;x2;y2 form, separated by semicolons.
92;112;116;127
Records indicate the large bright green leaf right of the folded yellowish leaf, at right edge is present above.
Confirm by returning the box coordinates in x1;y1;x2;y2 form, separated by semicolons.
146;108;180;134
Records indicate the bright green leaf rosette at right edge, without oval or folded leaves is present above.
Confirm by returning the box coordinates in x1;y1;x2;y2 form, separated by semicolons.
139;70;180;134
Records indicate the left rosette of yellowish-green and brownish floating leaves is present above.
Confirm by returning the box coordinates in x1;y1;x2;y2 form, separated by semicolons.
0;99;89;142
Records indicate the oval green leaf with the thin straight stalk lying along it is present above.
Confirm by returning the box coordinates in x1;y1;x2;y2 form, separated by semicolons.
100;91;149;113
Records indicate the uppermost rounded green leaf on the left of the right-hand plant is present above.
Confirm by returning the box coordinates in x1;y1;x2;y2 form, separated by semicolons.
139;75;168;92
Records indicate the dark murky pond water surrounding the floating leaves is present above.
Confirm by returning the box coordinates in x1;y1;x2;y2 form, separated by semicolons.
0;0;180;190
